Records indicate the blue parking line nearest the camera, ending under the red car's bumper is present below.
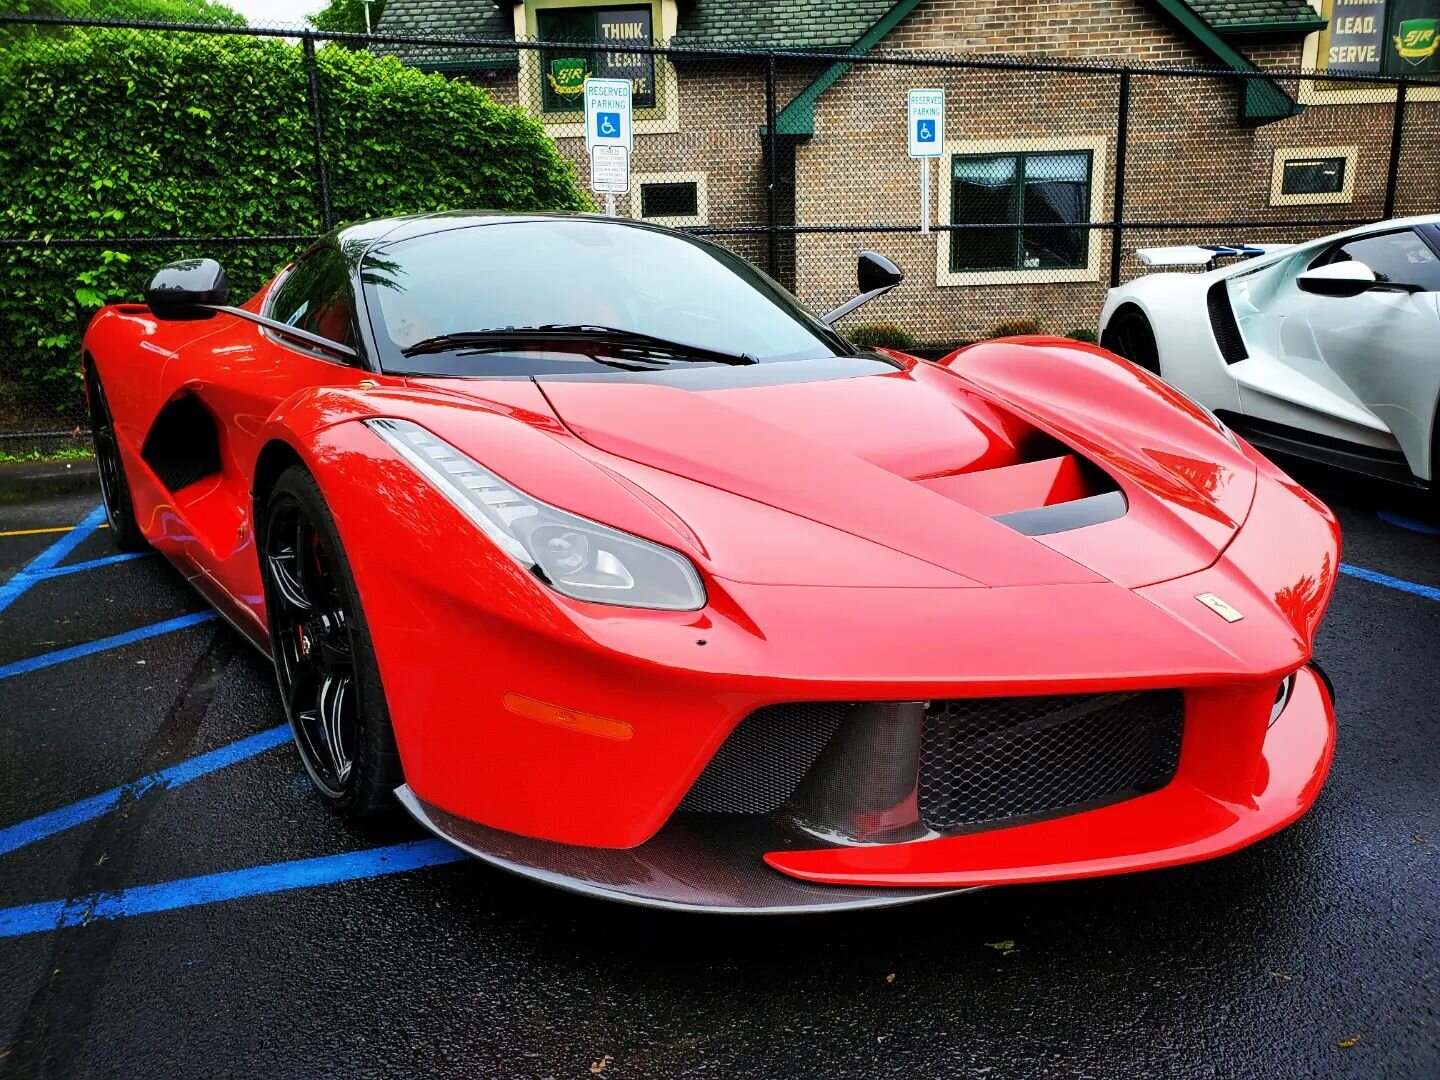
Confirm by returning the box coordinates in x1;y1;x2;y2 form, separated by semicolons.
0;840;468;937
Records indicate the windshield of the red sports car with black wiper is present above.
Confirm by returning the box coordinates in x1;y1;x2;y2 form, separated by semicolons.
361;217;852;376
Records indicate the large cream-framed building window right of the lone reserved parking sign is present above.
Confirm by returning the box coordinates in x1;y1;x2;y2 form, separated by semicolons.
950;150;1094;274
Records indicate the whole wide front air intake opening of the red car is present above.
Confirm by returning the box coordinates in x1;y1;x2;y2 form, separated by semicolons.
680;690;1185;840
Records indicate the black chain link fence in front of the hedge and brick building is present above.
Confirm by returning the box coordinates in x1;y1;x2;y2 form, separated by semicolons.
0;16;1440;454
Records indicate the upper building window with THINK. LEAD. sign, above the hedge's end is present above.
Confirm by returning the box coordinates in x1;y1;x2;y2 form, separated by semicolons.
536;4;655;112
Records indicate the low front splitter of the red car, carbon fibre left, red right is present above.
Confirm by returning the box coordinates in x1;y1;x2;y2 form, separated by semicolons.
397;667;1335;914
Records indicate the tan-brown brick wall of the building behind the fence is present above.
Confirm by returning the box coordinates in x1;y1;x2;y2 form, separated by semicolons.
455;0;1440;343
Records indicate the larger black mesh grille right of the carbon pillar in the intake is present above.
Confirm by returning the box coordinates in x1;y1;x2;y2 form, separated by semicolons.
920;690;1185;831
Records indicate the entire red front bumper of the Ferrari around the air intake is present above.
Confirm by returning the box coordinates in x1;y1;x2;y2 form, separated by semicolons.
309;425;1339;910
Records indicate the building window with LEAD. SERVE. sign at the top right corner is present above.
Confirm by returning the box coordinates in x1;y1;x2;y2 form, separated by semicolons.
1315;0;1440;77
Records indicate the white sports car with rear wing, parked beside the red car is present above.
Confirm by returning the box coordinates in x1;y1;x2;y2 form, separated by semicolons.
1100;215;1440;487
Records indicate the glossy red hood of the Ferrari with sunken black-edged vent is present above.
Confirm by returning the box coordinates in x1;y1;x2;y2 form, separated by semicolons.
521;364;1256;588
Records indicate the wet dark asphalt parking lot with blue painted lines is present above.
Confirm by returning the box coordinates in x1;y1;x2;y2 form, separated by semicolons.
0;474;1440;1079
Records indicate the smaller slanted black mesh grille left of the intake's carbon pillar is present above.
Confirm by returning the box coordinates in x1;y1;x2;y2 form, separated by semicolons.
680;701;854;814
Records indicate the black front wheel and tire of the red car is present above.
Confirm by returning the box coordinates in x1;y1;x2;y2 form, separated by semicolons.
259;465;403;821
